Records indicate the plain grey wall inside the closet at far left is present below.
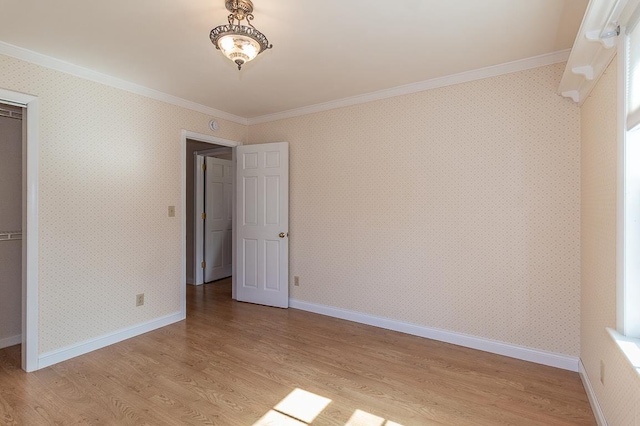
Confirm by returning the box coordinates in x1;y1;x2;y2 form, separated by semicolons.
0;117;22;348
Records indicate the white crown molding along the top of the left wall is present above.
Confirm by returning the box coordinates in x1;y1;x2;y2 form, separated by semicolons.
0;41;248;125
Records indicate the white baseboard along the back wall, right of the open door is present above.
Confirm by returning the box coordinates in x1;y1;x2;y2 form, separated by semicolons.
289;299;579;371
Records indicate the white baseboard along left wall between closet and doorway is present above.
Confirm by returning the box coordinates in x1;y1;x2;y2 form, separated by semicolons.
37;312;185;370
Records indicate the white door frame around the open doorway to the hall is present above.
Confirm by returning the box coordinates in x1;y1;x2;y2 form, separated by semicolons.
180;129;242;318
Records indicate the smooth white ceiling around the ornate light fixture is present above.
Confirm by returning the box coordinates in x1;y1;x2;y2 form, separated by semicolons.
0;0;588;118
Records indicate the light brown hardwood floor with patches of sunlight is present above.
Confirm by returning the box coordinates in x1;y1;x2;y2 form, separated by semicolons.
0;280;596;426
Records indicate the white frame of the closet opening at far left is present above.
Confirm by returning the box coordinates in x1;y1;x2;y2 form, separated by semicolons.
0;89;40;372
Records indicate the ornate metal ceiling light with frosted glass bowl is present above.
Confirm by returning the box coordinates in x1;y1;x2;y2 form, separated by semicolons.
209;0;273;70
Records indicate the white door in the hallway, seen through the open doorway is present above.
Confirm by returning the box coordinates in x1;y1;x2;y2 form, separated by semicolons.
204;157;233;282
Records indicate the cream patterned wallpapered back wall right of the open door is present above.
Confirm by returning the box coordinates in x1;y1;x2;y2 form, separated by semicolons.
249;64;580;356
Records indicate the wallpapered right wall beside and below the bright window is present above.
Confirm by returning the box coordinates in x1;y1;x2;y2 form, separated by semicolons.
580;60;640;426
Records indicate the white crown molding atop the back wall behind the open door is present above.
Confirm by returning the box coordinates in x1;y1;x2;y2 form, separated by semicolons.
248;49;570;125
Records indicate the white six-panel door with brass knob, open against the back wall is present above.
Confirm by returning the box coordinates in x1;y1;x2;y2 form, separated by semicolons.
234;142;289;308
